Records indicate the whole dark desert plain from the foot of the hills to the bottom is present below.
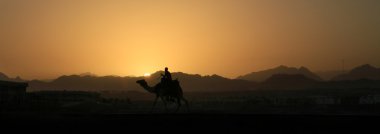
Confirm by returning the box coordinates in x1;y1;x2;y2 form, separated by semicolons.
0;90;380;134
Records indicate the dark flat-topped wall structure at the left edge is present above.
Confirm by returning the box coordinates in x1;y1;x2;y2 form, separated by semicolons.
0;81;28;105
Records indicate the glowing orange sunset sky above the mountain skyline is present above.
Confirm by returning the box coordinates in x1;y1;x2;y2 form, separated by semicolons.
0;0;380;79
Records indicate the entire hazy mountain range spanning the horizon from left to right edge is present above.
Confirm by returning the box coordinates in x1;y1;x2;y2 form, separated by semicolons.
0;64;380;92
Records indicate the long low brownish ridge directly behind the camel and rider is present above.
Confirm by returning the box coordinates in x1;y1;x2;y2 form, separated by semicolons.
28;71;256;92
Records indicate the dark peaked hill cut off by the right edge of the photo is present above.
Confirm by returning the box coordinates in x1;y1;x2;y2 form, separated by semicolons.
332;64;380;81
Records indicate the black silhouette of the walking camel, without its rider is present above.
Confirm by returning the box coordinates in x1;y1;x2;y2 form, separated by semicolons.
136;79;189;112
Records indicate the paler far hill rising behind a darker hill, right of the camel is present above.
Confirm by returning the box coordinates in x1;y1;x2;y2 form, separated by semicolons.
237;65;322;82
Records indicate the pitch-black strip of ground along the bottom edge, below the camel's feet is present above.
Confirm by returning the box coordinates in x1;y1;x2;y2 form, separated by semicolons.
1;114;380;133
